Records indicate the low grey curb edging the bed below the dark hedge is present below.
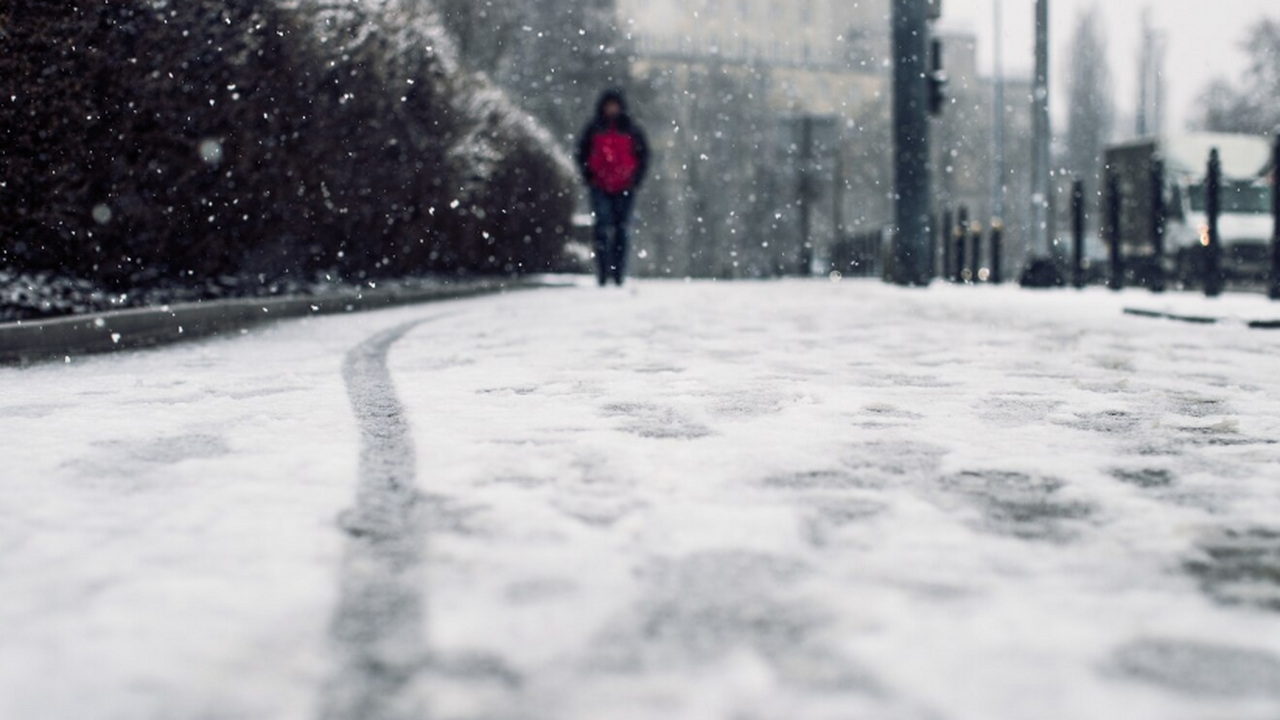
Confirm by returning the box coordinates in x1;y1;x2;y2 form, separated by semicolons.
0;275;556;365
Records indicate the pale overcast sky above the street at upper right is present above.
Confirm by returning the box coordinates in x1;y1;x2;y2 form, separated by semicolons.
942;0;1280;132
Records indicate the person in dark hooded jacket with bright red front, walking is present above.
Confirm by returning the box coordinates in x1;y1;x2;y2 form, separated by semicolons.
577;90;649;287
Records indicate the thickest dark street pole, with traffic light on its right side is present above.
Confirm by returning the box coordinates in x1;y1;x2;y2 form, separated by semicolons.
890;0;932;286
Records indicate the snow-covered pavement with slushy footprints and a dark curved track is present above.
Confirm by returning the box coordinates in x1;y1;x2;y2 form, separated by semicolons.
0;282;1280;720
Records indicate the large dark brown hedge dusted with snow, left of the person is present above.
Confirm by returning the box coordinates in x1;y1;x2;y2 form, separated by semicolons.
0;0;573;286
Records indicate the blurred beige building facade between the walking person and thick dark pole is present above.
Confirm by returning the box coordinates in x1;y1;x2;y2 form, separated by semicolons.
618;0;891;277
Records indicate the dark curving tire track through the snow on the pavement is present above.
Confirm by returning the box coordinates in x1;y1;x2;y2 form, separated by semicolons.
320;315;440;720
